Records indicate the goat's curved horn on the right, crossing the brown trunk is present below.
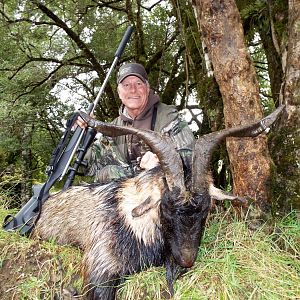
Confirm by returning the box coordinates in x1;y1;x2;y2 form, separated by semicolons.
192;105;285;192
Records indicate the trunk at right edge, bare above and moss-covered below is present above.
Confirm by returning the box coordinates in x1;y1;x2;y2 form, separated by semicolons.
271;0;300;209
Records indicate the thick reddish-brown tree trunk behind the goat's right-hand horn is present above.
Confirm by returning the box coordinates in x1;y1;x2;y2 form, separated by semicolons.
193;0;271;210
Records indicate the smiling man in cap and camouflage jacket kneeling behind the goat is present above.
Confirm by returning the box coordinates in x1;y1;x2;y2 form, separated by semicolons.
82;63;194;183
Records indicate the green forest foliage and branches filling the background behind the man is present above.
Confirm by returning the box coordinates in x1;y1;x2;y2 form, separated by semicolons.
0;0;287;213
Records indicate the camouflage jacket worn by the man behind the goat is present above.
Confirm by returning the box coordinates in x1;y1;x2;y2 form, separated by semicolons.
85;100;195;183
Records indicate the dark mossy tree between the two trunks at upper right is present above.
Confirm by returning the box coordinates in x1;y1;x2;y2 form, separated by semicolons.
236;0;288;105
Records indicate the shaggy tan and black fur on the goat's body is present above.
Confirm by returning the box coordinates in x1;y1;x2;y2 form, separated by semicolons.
34;168;170;299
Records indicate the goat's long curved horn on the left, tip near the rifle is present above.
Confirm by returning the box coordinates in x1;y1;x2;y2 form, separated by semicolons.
79;112;185;193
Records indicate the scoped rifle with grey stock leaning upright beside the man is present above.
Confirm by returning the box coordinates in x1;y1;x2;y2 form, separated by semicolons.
3;26;133;235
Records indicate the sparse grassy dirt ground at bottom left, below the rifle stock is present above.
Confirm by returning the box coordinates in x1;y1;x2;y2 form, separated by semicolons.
0;209;83;300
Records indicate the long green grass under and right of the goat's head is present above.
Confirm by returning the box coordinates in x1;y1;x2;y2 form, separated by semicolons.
121;214;300;300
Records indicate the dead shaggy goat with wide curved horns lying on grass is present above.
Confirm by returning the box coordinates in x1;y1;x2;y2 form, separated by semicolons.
34;106;283;300
